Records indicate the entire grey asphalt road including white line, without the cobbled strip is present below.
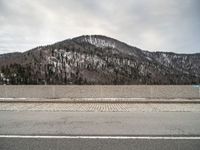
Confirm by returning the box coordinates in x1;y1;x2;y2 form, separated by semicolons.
0;111;200;150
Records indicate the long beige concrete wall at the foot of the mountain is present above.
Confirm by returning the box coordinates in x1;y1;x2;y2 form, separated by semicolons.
0;85;200;98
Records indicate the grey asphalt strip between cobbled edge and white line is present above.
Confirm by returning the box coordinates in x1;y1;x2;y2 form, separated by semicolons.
0;111;200;135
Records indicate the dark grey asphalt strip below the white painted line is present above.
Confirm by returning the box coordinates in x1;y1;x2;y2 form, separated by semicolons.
0;138;200;150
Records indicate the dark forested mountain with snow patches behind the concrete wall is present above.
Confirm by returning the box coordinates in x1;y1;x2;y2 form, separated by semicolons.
0;35;200;84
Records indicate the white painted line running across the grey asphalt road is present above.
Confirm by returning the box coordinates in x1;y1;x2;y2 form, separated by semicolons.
0;135;200;140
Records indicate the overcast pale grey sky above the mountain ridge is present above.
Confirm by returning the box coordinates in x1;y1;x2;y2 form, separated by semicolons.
0;0;200;53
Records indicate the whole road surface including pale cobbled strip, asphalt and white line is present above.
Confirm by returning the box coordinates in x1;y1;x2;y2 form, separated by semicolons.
0;101;200;150
